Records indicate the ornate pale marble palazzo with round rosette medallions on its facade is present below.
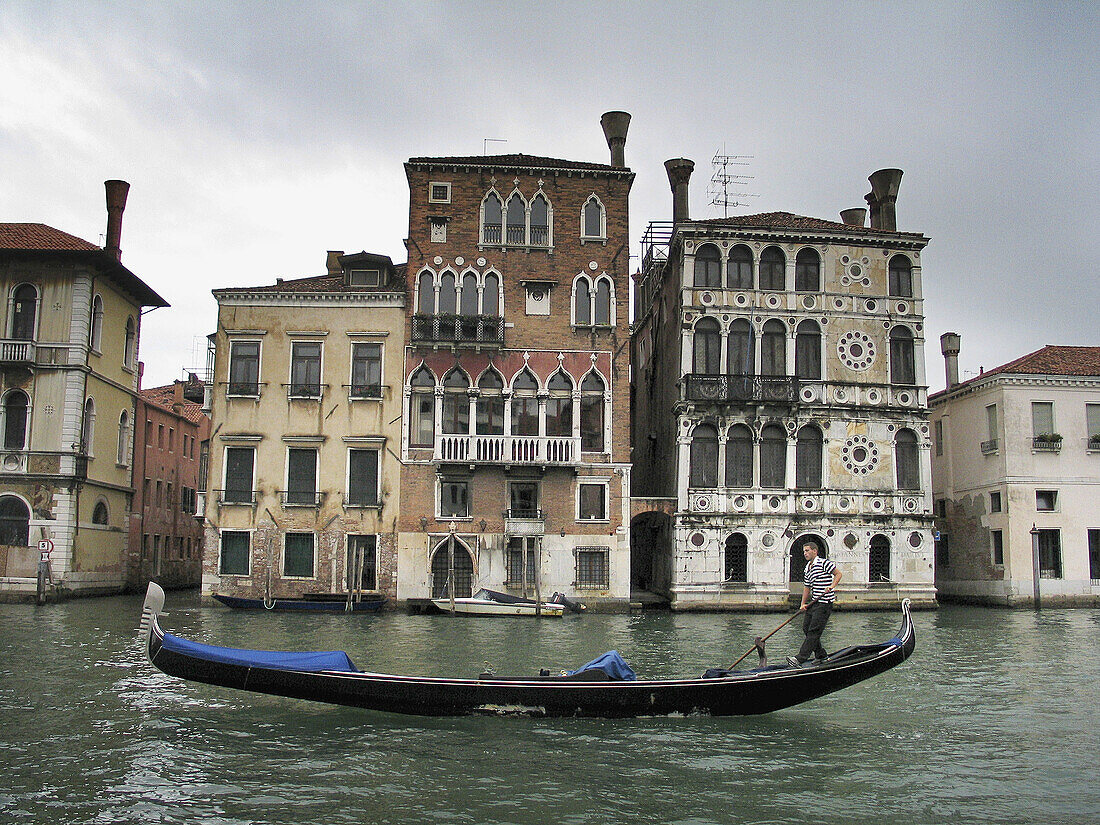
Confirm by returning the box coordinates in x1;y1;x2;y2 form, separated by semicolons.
633;165;934;609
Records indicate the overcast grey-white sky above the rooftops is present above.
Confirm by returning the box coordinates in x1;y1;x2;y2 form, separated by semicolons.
0;0;1100;389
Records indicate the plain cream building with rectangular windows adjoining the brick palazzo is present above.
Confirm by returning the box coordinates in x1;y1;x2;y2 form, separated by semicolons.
202;252;405;598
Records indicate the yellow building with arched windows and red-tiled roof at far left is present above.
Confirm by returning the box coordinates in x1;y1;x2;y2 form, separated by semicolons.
0;180;167;597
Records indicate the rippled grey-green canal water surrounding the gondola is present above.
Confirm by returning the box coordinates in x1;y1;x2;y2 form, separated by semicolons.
0;593;1100;825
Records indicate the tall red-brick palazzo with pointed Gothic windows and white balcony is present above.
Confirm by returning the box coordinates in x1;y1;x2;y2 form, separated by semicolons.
398;112;634;608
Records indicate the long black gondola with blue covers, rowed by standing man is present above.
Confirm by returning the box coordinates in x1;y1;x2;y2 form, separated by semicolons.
142;583;915;717
